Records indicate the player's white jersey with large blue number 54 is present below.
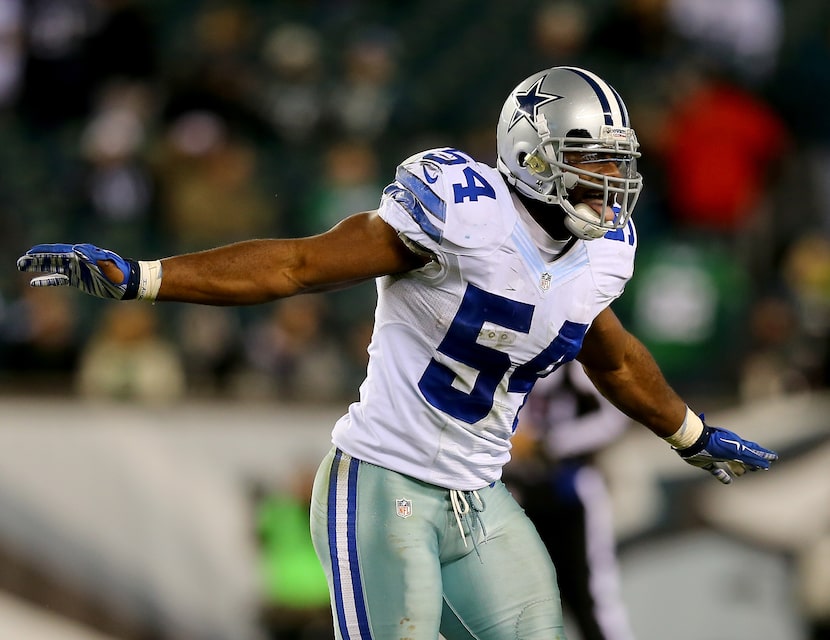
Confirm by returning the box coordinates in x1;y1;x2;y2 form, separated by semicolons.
332;149;636;490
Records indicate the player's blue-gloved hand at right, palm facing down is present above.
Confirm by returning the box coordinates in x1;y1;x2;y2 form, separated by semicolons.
677;415;778;484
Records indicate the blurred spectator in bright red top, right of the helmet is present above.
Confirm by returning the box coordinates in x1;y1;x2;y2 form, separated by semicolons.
659;64;790;286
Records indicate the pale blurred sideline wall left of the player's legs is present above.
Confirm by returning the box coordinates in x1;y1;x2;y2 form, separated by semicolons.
0;399;340;640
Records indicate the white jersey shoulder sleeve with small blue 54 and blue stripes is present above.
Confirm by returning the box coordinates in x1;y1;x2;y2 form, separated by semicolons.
378;149;516;255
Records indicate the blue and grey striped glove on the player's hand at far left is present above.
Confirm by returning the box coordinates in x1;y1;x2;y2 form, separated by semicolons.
17;244;140;300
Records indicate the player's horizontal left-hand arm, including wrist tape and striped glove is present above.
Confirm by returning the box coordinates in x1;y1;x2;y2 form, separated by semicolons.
17;212;424;305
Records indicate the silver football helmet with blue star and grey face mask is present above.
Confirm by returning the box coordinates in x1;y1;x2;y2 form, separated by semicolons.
496;67;643;239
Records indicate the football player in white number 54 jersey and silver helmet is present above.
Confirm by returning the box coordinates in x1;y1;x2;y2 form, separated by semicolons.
18;67;777;640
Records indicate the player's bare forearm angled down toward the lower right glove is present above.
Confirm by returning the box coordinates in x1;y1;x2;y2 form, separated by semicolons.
585;335;686;438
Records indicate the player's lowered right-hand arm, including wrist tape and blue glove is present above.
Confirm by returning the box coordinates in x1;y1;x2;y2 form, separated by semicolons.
578;309;778;484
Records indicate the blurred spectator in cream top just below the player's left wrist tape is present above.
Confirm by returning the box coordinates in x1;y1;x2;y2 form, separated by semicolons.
76;304;186;404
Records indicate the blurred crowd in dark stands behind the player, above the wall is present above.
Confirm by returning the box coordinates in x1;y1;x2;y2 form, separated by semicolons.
0;0;830;637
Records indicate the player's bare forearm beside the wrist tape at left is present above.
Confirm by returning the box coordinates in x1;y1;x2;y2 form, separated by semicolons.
157;240;306;305
